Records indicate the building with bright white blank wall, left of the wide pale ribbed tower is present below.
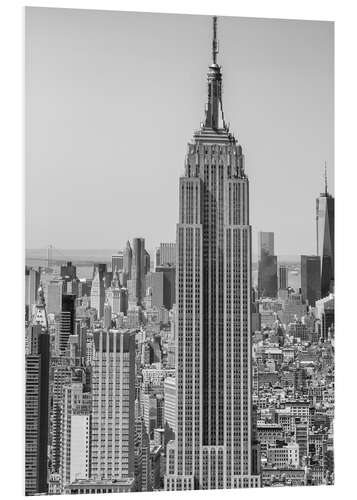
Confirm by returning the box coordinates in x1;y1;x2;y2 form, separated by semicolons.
60;376;91;490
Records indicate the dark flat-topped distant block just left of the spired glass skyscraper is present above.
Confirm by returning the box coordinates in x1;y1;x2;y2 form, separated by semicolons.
301;255;321;307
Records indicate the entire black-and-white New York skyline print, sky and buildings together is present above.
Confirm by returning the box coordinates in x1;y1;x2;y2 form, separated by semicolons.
21;3;336;498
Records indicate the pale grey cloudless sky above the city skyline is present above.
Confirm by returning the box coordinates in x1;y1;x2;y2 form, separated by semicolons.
26;8;334;254
